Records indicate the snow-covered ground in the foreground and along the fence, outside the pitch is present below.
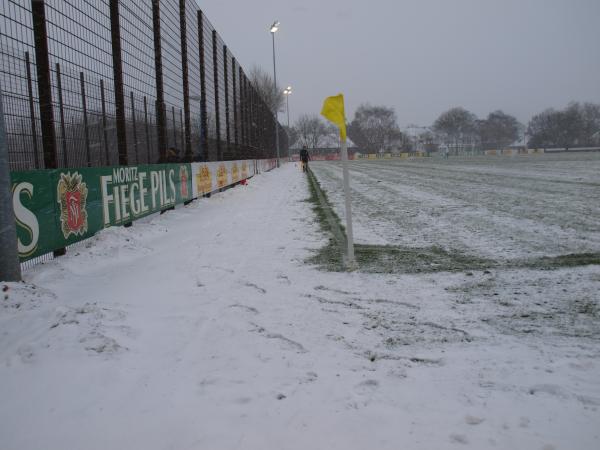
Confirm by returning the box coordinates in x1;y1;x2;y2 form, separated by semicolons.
0;164;600;450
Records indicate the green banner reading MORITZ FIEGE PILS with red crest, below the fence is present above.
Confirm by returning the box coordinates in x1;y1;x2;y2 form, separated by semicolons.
11;164;192;261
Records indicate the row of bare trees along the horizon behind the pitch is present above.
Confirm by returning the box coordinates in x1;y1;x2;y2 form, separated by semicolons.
250;66;600;153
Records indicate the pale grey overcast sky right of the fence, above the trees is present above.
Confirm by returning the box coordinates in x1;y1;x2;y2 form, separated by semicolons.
197;0;600;127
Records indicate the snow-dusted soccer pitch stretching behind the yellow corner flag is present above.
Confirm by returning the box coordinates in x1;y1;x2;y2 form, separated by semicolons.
311;153;600;271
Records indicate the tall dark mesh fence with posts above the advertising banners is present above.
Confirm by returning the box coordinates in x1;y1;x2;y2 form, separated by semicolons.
0;0;287;170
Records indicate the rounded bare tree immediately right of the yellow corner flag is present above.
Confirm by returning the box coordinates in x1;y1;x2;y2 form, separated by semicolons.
348;104;402;153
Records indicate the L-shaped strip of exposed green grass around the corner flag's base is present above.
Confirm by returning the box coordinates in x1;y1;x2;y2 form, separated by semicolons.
307;170;600;274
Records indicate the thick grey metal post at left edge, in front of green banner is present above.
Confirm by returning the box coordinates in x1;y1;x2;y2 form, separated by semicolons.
0;86;21;281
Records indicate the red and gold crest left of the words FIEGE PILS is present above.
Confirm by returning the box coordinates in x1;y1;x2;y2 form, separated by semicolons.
56;172;88;239
